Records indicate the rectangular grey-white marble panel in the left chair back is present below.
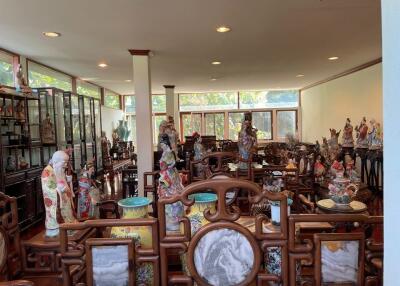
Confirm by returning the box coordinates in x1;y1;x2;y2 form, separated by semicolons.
92;245;129;286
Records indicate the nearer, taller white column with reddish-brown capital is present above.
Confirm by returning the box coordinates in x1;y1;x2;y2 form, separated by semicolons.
129;50;153;196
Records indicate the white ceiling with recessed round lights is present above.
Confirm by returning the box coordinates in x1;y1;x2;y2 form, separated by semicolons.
0;0;382;94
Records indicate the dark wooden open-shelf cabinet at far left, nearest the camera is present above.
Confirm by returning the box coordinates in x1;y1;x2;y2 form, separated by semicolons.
0;89;44;230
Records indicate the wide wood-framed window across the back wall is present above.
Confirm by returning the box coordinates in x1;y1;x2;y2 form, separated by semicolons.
179;90;299;141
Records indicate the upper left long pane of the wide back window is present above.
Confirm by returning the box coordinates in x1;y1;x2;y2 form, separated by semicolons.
179;92;237;111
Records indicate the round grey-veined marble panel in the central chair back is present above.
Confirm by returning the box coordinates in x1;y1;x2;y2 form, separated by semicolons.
194;228;254;285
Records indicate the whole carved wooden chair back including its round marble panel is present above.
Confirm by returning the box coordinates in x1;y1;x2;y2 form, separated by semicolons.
158;179;288;285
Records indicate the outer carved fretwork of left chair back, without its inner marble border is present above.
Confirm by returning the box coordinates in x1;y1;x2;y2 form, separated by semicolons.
60;217;160;286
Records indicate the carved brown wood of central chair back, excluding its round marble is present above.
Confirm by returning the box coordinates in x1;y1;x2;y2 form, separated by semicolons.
158;178;289;285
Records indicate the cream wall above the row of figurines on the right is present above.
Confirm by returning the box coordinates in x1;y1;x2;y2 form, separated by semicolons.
301;64;383;142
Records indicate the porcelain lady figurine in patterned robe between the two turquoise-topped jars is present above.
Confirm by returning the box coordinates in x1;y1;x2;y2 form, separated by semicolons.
158;134;183;231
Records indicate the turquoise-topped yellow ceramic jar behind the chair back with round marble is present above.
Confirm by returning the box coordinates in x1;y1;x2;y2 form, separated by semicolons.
181;193;217;275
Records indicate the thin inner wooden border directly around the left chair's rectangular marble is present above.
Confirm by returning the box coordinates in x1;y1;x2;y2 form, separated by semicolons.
85;238;135;286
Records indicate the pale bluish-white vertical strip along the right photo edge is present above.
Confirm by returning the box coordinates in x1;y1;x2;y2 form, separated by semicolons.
381;0;400;285
